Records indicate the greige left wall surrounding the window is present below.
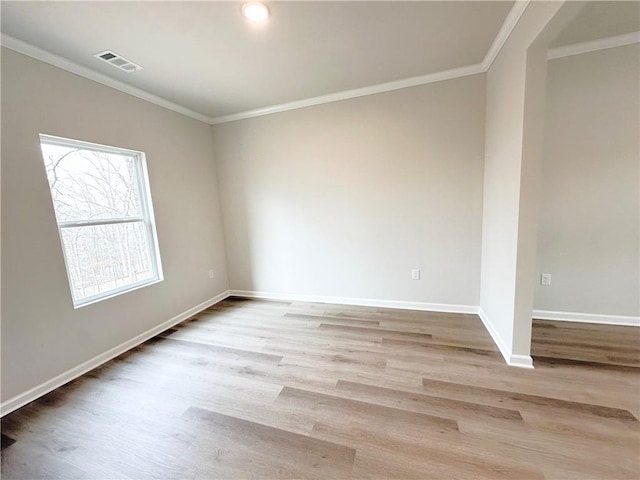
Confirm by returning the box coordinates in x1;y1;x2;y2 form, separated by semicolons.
2;49;228;403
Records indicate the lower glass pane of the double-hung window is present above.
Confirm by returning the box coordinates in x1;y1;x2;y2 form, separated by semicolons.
61;222;154;301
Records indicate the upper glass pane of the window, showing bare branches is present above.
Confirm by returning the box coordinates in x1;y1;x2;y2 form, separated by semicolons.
41;142;142;222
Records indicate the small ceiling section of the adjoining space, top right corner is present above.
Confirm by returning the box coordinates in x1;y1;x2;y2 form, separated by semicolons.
550;0;640;48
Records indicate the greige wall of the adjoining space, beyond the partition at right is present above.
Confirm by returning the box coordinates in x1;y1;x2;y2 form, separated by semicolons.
535;44;640;320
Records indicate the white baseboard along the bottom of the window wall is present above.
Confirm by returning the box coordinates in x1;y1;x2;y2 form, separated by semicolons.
0;290;229;417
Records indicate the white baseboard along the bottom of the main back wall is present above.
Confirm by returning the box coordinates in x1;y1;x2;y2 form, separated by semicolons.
230;290;478;314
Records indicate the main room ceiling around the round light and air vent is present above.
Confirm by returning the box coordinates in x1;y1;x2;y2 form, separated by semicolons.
2;1;514;118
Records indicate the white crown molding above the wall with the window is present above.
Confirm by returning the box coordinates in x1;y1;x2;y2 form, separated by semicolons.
0;33;211;123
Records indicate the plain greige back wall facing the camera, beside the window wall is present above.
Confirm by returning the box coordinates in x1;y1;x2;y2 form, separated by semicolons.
213;75;485;306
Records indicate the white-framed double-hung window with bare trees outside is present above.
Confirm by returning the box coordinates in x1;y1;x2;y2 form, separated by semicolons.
40;135;162;308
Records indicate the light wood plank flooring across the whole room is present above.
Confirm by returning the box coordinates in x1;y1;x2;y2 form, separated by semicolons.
1;299;640;479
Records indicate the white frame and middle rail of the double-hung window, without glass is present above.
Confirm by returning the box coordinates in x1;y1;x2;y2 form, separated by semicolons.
39;133;164;308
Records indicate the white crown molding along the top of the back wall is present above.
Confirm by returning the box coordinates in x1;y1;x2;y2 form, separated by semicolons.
210;63;485;125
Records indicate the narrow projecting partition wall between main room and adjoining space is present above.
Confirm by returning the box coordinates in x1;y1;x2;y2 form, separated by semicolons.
480;2;579;367
